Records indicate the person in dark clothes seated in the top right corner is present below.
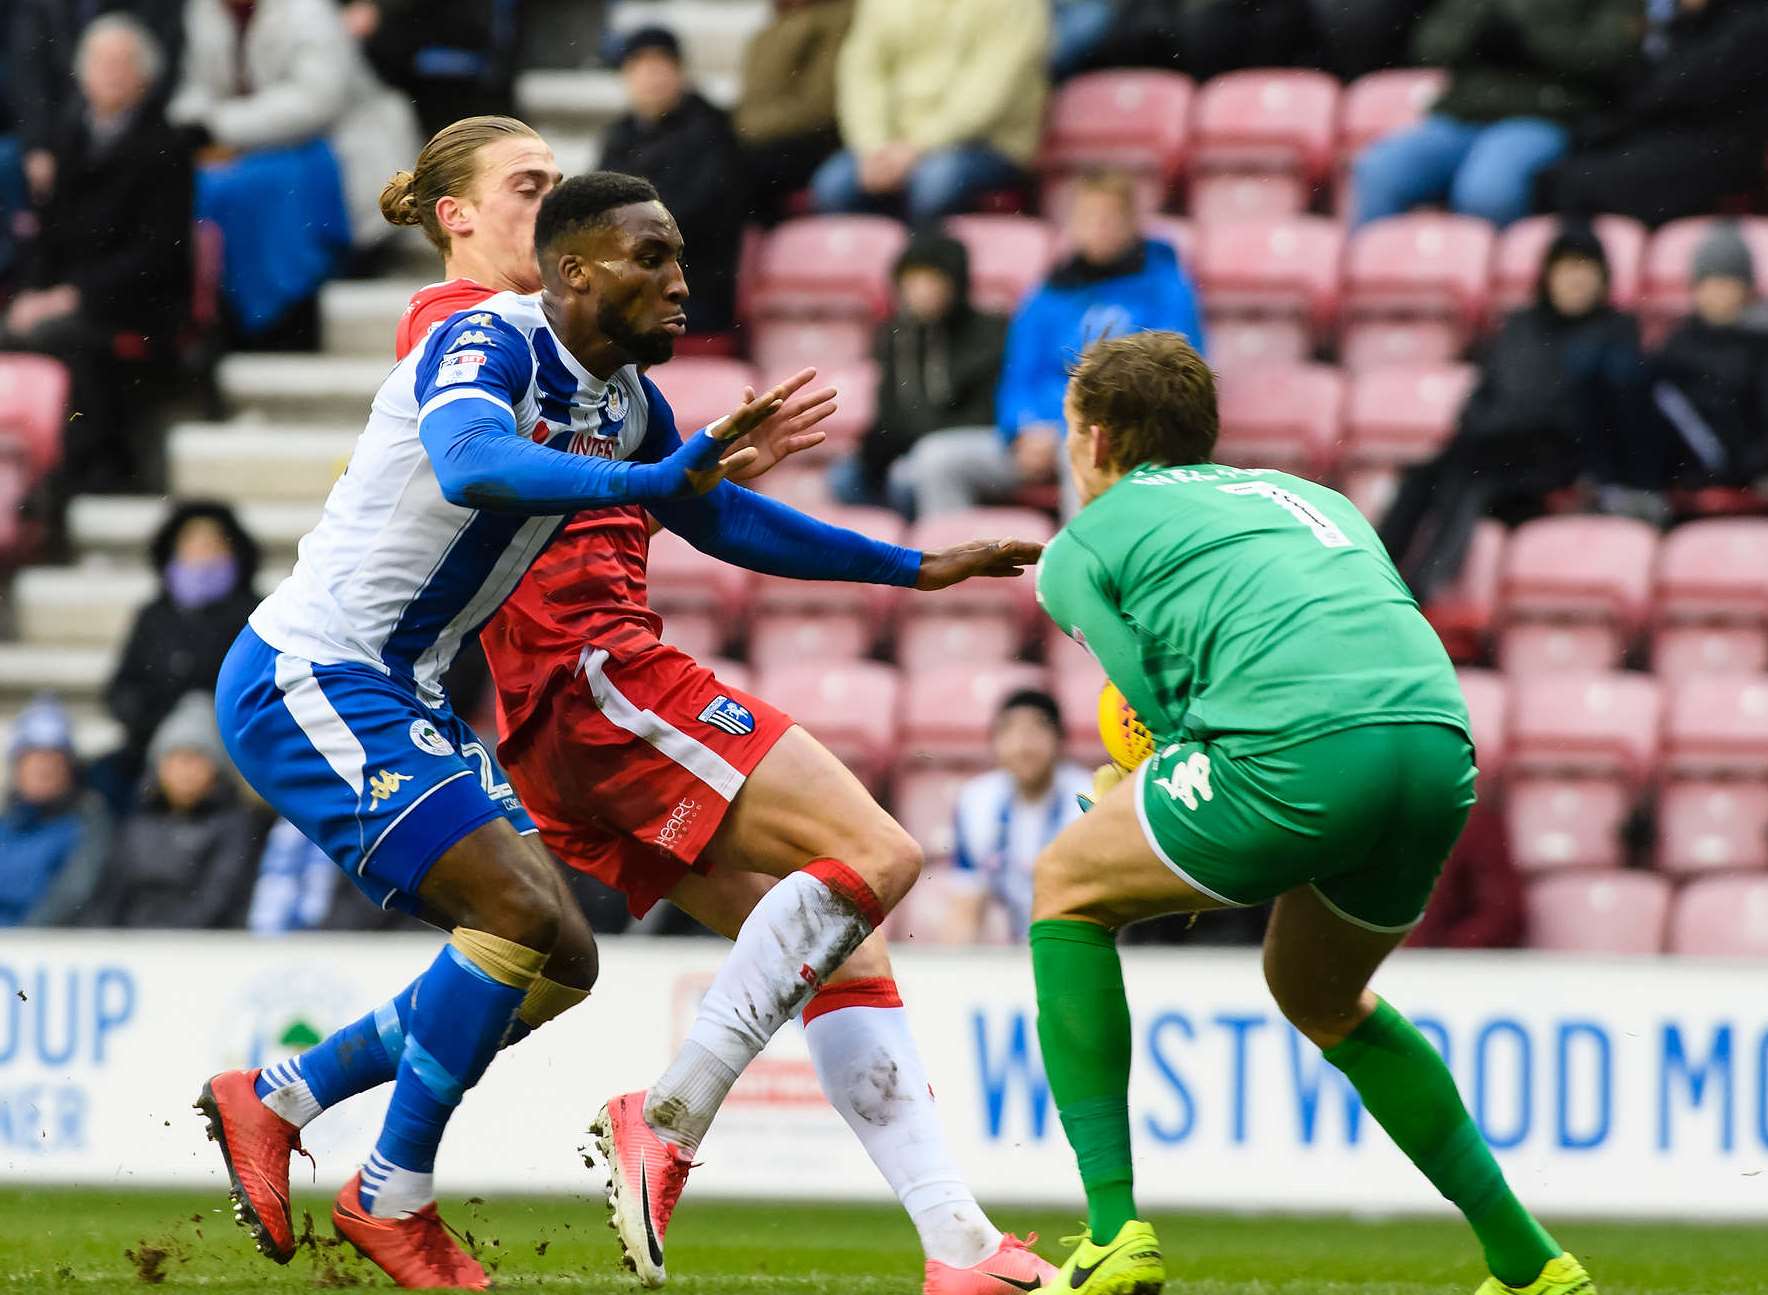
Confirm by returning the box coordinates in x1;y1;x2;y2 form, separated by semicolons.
1545;0;1768;225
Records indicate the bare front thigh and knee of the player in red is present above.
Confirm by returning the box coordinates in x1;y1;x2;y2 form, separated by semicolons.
704;725;921;908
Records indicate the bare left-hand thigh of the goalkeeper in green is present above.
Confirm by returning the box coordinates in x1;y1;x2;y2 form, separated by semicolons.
1031;757;1223;931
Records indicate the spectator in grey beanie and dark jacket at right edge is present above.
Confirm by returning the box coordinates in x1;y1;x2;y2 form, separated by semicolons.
1637;223;1768;488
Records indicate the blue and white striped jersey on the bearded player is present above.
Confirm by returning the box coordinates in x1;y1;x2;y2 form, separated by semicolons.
251;292;681;706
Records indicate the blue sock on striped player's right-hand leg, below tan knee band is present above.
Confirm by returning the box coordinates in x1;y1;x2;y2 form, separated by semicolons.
361;945;523;1210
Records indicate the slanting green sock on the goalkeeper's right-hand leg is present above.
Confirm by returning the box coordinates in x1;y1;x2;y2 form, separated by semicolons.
1326;1001;1559;1286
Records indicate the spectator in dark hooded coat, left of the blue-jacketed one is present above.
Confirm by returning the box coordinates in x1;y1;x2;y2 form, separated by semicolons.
831;232;1006;513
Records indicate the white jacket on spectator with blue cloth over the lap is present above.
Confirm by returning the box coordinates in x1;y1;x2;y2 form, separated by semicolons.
166;0;421;246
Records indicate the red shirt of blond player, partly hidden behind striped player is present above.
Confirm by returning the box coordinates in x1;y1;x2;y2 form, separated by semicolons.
396;280;663;741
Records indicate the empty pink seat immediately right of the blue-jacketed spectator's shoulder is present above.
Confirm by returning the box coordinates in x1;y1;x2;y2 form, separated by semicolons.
1197;216;1344;366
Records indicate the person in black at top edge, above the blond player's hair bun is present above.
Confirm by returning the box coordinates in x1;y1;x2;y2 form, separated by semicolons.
343;0;522;138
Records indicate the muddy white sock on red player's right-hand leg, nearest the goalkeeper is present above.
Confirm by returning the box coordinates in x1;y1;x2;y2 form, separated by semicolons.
804;1005;1001;1268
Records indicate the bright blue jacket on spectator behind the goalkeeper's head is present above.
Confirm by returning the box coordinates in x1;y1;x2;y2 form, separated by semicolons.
995;239;1206;441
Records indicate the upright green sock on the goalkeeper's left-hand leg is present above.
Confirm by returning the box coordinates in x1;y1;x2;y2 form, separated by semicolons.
1031;922;1135;1245
